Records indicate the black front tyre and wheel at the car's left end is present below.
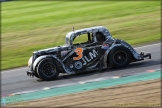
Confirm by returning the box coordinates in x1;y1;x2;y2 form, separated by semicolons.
37;58;59;81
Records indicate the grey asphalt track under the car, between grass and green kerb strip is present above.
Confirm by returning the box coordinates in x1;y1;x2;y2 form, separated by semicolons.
1;43;162;95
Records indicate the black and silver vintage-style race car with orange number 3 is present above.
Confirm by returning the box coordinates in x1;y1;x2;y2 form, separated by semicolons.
27;26;151;81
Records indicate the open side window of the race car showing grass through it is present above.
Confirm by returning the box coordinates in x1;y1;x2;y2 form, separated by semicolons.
73;34;88;44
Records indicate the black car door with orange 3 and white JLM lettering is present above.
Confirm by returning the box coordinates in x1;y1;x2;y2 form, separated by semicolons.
72;43;104;72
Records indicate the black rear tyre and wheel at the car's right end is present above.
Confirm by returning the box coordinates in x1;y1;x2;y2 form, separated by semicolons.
108;46;131;68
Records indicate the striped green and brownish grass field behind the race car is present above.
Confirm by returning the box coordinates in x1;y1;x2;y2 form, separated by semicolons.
1;1;160;70
